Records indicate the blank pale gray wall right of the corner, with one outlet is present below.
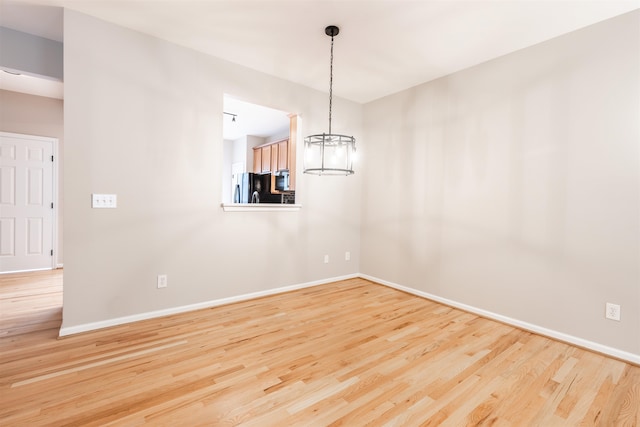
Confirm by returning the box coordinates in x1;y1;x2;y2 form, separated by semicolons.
361;11;640;355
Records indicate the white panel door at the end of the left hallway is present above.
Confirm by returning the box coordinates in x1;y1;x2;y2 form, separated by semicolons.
0;133;54;273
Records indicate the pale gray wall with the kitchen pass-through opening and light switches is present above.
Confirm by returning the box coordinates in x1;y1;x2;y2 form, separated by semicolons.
63;10;362;328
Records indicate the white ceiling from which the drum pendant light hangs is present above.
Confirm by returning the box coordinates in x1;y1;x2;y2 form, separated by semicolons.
0;0;640;103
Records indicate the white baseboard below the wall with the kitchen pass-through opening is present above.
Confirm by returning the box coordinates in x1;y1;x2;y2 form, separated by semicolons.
58;274;360;337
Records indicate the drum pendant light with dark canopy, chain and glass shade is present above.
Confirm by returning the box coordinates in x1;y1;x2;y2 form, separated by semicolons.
304;25;356;175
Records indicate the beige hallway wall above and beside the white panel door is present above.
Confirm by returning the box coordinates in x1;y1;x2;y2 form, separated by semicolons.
0;90;64;264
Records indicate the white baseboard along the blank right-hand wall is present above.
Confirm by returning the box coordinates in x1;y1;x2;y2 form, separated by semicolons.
359;274;640;365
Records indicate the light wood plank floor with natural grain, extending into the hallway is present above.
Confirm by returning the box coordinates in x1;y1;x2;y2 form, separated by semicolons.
0;272;640;427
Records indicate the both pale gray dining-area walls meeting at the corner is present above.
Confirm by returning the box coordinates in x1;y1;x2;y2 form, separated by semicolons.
58;11;640;360
